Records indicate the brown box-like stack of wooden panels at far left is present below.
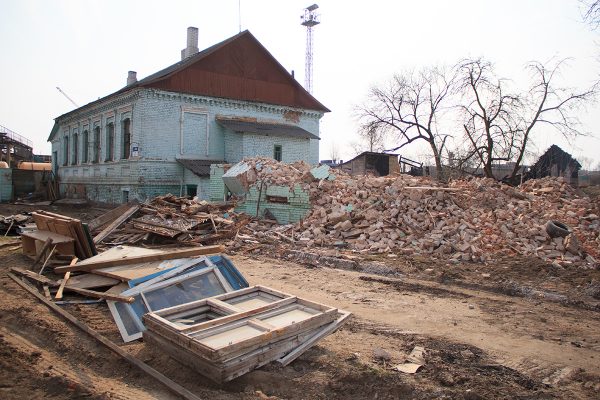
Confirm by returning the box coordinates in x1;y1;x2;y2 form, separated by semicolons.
22;210;97;260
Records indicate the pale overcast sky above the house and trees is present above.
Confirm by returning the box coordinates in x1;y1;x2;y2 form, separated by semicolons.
0;0;600;167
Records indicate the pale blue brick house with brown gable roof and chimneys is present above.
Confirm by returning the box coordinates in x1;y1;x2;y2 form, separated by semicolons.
48;28;329;203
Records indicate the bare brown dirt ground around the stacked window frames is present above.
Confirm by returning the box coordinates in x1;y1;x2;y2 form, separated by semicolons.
0;205;600;399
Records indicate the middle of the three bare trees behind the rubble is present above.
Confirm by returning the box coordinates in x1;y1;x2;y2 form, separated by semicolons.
458;59;520;178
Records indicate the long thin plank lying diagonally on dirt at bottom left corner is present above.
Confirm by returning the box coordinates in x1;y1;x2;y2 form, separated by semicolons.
9;274;201;400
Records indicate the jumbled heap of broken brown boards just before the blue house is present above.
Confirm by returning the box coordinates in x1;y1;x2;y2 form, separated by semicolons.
90;194;250;245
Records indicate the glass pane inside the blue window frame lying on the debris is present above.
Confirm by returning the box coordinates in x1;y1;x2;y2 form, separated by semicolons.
144;272;225;311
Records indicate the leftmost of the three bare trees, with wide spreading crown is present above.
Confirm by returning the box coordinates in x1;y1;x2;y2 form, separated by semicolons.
358;68;454;177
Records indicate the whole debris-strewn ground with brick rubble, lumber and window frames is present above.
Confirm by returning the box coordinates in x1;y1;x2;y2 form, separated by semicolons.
0;158;600;399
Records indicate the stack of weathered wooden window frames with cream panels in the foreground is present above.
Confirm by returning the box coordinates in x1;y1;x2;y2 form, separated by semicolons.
143;286;350;383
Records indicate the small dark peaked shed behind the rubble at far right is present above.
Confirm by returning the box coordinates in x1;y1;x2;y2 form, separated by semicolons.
525;144;581;185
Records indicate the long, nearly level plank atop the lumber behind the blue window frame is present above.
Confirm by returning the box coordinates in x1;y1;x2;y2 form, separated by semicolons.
54;245;225;273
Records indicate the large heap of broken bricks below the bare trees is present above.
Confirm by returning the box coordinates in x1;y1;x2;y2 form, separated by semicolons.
284;171;600;264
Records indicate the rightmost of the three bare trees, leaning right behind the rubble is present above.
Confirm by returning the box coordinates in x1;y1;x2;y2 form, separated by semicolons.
511;60;598;178
